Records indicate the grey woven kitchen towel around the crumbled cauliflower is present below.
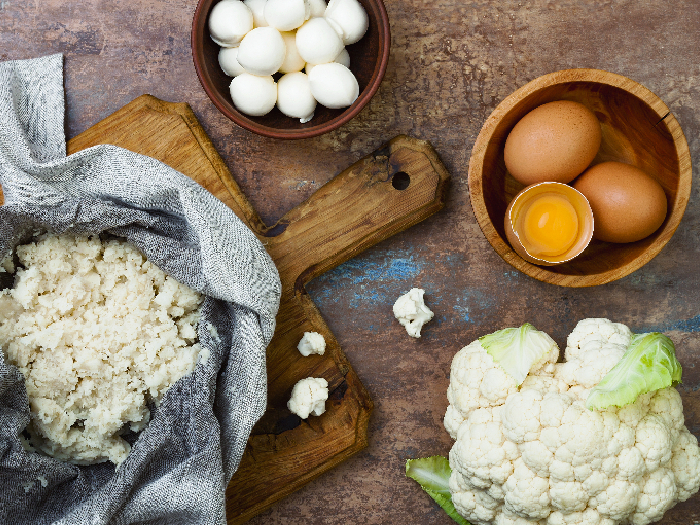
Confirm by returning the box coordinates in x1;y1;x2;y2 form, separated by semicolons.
0;55;281;525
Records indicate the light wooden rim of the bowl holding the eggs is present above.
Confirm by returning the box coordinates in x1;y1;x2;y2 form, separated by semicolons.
468;68;693;288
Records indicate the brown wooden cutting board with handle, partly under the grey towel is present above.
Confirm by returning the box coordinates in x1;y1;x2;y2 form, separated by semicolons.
56;95;449;524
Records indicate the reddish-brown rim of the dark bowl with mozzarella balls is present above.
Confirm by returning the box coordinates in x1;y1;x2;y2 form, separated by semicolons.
190;0;391;139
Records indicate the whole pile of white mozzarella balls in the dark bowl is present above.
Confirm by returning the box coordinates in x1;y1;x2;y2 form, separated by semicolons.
209;0;369;123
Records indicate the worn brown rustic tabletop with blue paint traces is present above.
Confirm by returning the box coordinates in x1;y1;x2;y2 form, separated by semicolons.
0;0;700;525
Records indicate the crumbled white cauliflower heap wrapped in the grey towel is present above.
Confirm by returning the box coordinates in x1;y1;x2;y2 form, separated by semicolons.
0;234;202;465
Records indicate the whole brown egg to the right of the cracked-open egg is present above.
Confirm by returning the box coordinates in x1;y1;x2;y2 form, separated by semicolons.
573;162;667;242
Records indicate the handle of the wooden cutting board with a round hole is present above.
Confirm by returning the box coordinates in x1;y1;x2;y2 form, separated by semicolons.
263;135;450;287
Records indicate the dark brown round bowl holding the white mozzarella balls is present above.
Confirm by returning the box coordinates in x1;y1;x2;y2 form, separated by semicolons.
192;0;391;139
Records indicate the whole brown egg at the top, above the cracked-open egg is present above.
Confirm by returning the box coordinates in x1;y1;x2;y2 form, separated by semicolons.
504;100;601;186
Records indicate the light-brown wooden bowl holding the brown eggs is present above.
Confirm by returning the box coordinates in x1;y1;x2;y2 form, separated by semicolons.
469;69;692;287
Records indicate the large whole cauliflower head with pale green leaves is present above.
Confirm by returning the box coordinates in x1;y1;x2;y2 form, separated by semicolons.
407;319;700;525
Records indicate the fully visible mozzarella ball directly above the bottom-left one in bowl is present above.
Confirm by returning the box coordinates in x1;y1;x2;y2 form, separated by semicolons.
238;27;287;77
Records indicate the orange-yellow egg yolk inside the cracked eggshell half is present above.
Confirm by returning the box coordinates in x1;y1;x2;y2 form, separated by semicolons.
522;194;578;257
